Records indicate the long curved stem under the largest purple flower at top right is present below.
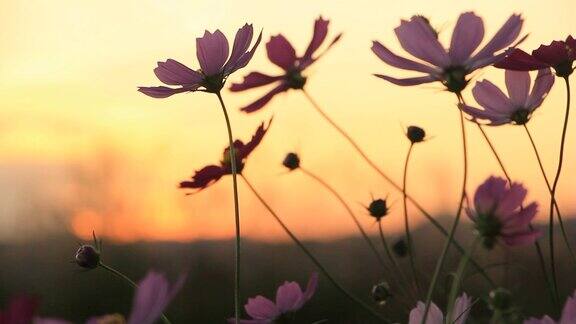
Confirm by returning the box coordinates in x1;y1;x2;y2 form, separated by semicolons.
420;106;468;324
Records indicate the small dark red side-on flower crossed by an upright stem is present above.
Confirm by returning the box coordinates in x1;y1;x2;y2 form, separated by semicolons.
180;120;272;190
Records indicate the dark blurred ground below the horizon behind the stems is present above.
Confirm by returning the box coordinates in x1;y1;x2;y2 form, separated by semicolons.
0;216;576;324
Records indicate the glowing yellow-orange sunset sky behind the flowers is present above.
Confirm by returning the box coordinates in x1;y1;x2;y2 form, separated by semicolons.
0;0;576;242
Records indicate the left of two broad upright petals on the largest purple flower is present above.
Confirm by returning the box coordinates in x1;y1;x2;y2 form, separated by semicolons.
394;16;450;67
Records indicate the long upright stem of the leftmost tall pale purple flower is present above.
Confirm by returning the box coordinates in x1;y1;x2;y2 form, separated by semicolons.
216;92;240;324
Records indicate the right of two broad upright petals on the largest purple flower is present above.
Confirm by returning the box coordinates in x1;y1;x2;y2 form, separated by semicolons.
448;12;484;64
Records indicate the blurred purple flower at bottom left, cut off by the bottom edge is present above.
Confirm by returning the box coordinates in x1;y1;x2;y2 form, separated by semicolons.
86;271;186;324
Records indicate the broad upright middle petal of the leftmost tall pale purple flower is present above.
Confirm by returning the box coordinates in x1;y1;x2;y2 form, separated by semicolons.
196;30;229;76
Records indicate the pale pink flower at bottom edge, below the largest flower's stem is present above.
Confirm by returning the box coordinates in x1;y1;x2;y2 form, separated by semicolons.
408;293;472;324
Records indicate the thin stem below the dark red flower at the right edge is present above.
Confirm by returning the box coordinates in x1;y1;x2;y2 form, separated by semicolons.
548;77;570;306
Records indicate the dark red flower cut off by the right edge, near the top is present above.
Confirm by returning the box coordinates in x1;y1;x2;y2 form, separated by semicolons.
494;36;576;77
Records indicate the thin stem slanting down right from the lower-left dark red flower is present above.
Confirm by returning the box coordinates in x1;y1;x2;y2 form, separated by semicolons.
240;174;391;323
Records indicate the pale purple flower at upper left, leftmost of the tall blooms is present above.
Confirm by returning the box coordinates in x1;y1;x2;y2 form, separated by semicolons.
138;24;262;98
